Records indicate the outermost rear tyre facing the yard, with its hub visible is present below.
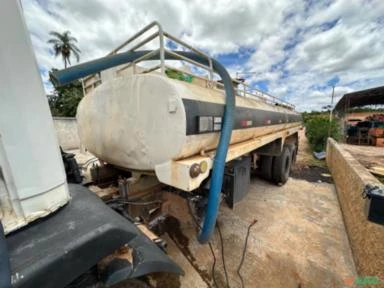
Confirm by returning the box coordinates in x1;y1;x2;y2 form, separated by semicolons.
272;146;292;184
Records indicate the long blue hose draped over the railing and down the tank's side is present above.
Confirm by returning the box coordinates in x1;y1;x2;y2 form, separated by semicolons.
51;51;236;243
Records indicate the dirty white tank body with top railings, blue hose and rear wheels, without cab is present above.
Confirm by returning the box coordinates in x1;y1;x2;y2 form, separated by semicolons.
51;22;302;243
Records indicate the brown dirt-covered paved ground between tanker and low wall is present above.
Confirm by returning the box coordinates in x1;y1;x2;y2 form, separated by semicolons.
158;130;356;288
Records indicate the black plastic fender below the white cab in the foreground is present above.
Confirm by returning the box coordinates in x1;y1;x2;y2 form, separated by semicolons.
6;185;183;287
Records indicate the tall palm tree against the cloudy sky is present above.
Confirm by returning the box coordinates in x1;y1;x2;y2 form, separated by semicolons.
48;31;81;68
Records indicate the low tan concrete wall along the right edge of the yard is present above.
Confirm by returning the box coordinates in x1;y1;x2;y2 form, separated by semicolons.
327;138;384;277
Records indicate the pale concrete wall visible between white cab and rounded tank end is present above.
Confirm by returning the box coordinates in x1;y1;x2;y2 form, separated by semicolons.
53;117;80;150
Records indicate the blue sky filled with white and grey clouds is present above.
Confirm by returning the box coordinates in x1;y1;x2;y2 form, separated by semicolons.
21;0;384;111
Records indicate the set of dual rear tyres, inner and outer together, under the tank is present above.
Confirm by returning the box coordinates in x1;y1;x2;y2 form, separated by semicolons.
260;144;297;184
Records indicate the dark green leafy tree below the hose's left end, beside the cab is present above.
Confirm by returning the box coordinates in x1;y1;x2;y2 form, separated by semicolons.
48;69;83;117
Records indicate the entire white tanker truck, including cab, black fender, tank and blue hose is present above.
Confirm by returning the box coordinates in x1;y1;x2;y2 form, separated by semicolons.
0;0;301;287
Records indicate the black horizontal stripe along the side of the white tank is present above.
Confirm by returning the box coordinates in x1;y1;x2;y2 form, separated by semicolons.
183;98;302;135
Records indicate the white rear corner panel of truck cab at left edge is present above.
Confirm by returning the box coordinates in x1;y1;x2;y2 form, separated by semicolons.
0;1;70;234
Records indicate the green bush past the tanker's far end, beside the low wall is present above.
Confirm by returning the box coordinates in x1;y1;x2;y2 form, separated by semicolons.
305;117;340;152
